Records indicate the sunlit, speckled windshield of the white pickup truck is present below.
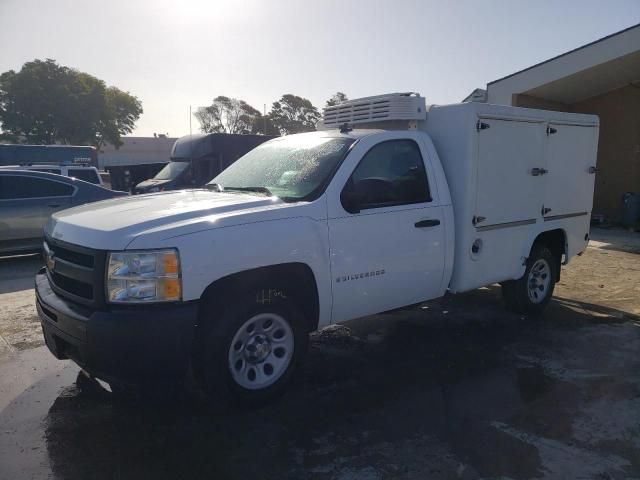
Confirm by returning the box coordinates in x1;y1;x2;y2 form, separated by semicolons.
210;133;354;201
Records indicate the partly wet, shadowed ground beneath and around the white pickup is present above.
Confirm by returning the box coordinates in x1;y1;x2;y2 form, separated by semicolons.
0;230;640;480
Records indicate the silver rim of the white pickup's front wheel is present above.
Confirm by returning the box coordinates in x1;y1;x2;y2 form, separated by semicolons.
228;313;294;390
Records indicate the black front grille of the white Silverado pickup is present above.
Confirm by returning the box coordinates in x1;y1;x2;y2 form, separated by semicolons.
44;237;106;308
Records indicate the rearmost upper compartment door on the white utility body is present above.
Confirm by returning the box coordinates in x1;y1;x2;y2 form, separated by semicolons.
544;123;598;217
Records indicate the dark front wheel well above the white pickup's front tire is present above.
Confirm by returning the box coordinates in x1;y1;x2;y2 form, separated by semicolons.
201;263;320;332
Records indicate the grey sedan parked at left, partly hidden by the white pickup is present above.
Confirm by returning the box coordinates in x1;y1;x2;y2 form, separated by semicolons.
0;168;127;255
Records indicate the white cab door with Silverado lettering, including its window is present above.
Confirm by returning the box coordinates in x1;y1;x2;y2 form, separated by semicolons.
327;132;445;322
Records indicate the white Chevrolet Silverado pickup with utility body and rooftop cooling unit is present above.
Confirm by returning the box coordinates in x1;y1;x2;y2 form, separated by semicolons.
36;94;598;403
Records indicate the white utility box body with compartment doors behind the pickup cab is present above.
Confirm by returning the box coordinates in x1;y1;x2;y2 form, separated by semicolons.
423;103;598;292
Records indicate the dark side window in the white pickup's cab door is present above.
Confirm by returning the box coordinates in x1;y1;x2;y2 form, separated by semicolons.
340;140;431;212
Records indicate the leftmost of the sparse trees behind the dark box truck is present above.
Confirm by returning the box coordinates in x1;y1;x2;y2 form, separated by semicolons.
194;95;264;134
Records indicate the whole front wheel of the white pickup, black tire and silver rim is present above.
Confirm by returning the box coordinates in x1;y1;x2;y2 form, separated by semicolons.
200;297;308;405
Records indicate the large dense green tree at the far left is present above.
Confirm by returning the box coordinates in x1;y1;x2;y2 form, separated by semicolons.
0;59;142;147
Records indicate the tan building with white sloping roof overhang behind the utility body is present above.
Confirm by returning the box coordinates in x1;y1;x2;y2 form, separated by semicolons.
478;24;640;220
